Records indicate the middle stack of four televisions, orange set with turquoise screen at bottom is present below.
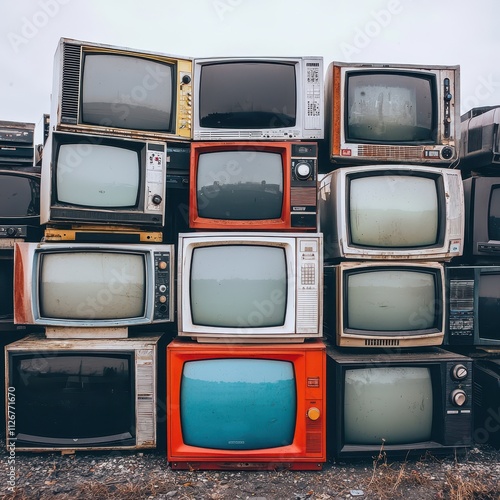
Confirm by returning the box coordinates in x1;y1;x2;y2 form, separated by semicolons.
167;57;326;470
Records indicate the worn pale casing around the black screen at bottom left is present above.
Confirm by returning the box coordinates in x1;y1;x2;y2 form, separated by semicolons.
4;333;165;453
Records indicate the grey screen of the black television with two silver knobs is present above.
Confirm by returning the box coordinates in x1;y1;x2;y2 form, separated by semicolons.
344;367;433;445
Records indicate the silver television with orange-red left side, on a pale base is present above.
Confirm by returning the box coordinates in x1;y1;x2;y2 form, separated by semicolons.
14;242;174;338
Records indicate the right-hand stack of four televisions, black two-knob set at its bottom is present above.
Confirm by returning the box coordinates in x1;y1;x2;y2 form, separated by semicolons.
318;58;472;458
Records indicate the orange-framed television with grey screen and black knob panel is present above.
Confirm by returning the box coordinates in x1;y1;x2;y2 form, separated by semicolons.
189;141;318;231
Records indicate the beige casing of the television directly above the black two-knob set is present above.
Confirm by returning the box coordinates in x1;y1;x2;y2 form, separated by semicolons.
324;260;447;349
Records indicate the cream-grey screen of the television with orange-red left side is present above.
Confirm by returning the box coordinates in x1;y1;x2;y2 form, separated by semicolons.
39;251;146;320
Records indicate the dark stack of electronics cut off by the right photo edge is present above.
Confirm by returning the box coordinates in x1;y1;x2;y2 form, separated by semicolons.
452;106;500;446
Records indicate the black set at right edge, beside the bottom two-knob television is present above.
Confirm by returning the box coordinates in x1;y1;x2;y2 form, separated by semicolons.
473;353;500;448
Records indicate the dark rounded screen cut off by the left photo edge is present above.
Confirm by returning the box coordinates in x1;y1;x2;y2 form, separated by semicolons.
0;174;40;217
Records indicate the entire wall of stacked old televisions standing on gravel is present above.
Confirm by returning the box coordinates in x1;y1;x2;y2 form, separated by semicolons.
4;38;500;470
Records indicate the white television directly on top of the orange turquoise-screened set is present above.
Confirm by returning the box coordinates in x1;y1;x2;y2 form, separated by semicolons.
177;231;323;343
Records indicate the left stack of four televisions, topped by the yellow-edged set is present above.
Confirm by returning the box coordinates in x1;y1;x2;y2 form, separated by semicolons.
2;38;192;452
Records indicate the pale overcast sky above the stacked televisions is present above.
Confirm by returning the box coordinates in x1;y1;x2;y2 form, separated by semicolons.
0;0;500;142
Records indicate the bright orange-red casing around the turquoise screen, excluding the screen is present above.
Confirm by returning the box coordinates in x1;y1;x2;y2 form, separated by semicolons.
167;338;326;470
